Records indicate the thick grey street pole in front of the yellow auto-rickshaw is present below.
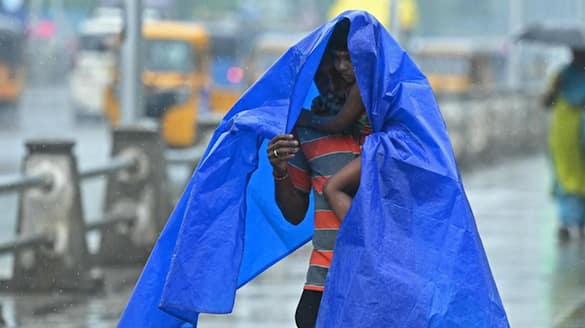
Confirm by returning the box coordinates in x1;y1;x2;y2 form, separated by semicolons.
120;0;144;125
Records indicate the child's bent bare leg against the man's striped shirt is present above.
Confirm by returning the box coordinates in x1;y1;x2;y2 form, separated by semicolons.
323;157;362;220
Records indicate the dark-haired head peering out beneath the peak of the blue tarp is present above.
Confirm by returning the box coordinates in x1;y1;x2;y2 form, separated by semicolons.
327;18;355;83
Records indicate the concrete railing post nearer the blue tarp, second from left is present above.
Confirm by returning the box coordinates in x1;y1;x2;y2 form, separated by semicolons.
99;126;171;264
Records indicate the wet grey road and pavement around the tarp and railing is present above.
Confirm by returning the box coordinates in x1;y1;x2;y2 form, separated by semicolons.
0;87;585;328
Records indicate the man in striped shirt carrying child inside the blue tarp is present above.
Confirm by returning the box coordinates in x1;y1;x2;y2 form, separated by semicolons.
268;21;367;327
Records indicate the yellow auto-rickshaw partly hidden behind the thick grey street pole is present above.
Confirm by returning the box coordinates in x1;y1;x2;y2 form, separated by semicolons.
106;21;209;148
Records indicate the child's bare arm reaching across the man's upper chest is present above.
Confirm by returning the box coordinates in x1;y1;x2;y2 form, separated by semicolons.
301;83;364;133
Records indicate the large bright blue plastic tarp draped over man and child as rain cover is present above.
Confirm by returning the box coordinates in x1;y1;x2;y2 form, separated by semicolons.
119;11;509;327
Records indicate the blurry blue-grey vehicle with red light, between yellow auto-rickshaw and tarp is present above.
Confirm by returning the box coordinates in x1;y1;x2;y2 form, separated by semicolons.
207;25;247;117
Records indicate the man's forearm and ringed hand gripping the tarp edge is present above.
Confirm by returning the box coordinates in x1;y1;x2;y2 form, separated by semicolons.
267;134;309;225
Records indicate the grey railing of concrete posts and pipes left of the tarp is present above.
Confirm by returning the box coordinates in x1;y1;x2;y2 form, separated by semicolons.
0;126;205;291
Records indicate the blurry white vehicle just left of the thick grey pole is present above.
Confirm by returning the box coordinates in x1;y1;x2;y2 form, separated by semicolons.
69;15;123;117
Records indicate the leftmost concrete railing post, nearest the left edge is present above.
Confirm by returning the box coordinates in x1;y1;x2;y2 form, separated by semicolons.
11;140;91;291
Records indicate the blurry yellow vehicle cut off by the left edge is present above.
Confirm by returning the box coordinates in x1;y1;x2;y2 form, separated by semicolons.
0;15;25;107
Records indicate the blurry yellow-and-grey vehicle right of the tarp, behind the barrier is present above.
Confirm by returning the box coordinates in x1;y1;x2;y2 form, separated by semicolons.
410;39;506;97
